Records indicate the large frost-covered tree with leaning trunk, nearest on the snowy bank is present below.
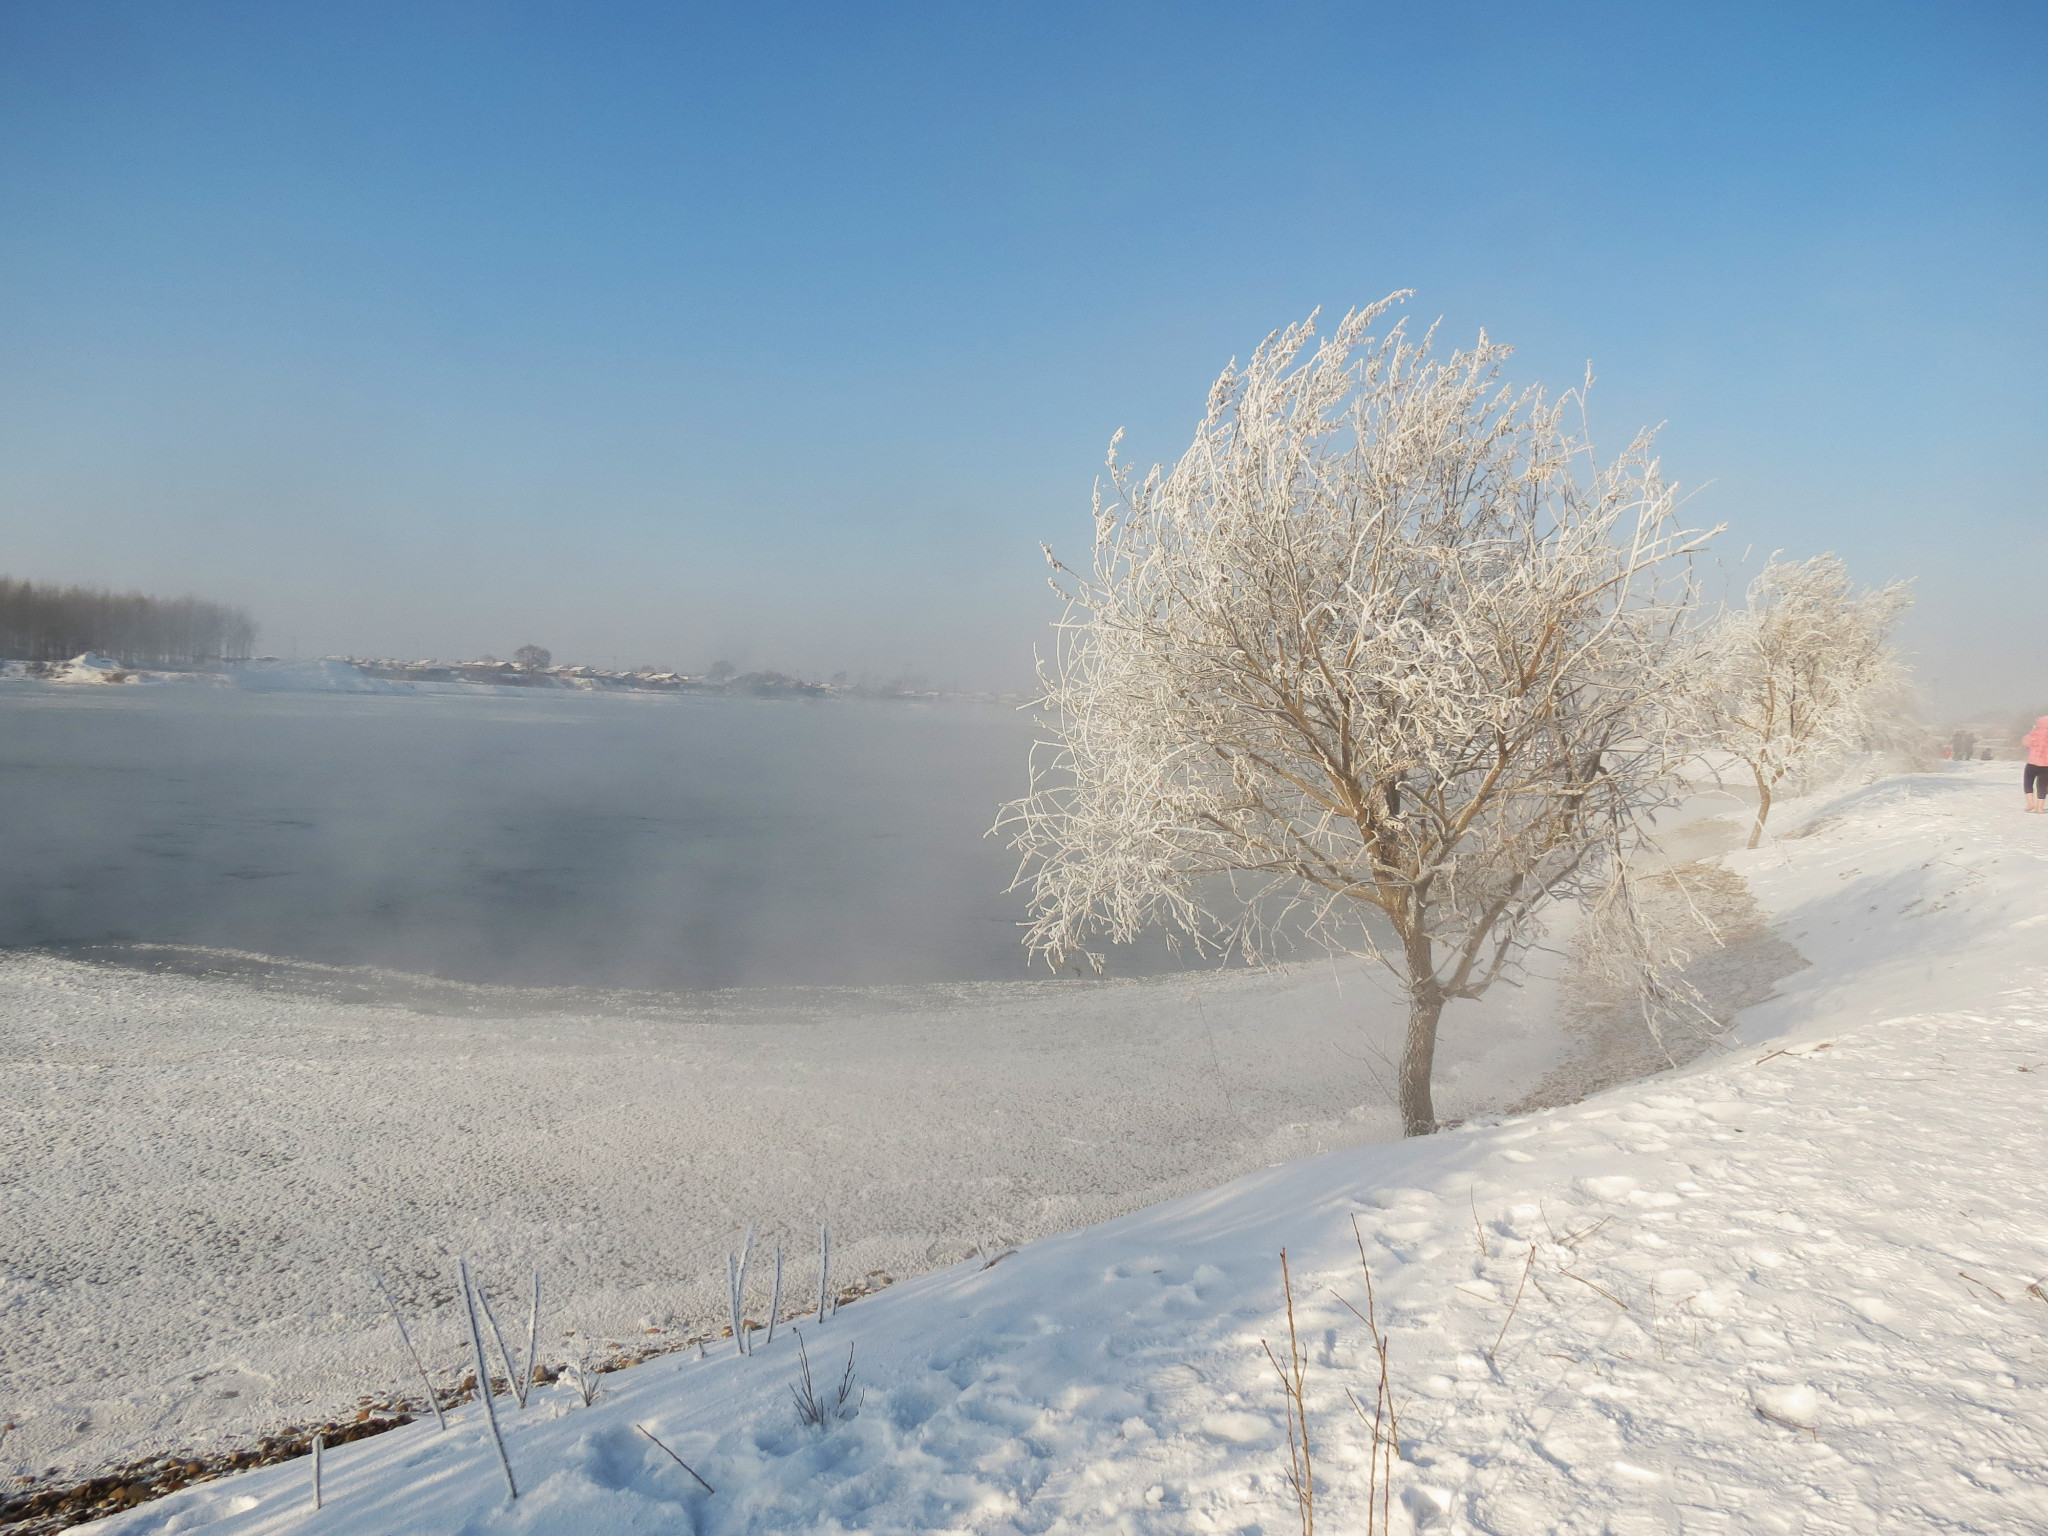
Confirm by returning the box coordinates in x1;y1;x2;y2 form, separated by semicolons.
999;295;1698;1135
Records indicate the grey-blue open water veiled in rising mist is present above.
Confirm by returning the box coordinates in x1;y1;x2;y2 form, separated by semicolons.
0;688;1169;989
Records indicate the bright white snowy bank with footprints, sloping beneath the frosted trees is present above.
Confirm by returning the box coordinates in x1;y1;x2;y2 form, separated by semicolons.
36;764;2048;1536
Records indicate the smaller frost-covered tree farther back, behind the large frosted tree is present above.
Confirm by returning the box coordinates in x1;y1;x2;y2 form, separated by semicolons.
1694;553;1913;848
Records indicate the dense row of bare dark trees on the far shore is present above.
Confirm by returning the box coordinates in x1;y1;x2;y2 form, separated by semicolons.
0;575;256;668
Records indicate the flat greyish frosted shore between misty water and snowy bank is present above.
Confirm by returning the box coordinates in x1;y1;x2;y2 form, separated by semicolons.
0;937;1569;1468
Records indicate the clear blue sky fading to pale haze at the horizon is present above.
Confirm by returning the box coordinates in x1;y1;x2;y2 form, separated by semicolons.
0;0;2048;709
